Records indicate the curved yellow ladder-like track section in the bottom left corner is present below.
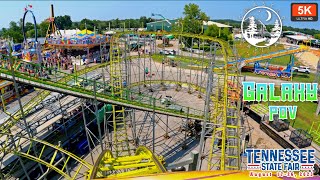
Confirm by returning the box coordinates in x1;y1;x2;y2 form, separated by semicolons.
0;133;93;179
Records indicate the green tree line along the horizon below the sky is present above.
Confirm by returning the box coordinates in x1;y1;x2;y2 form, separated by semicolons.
0;3;320;44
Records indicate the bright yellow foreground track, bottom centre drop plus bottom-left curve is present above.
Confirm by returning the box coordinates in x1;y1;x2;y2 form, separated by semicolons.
0;133;166;180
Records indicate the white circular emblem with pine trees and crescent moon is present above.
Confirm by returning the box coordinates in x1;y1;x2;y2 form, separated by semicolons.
241;6;282;47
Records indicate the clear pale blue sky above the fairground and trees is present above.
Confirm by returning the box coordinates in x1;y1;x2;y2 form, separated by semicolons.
0;0;320;30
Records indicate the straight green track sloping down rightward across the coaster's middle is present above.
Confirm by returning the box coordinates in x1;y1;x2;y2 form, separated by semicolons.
0;64;204;121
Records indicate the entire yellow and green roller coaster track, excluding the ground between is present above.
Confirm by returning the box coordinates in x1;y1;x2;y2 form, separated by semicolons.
0;28;310;179
